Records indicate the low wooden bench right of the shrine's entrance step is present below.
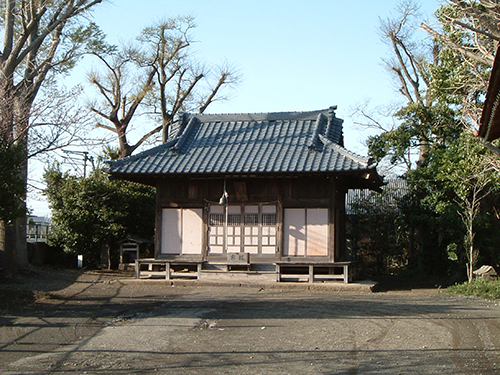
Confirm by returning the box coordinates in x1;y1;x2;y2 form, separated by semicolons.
275;262;356;284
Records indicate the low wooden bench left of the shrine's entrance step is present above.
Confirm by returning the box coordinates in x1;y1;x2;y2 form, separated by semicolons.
135;258;203;280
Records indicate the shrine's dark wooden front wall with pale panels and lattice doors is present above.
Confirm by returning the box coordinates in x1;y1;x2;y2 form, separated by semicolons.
155;176;347;263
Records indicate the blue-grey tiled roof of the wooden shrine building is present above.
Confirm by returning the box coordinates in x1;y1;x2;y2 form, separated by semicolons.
107;107;375;175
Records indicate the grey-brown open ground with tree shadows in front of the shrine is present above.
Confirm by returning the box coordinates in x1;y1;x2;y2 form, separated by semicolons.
0;271;500;375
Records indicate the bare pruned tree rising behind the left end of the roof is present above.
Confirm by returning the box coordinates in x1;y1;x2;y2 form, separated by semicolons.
90;17;238;158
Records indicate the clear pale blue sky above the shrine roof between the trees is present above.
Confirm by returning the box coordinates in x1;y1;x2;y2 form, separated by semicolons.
29;0;440;215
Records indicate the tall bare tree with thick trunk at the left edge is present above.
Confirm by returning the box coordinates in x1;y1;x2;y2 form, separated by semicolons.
0;0;106;273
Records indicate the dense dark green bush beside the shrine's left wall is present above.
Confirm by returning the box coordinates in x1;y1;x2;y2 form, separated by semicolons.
45;165;155;267
